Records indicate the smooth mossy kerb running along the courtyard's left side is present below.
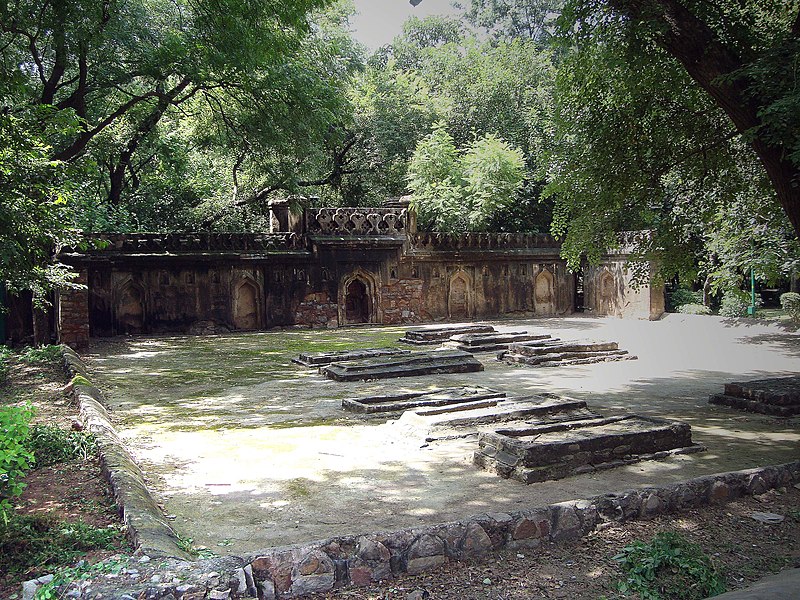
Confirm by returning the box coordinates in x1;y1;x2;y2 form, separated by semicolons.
61;345;189;559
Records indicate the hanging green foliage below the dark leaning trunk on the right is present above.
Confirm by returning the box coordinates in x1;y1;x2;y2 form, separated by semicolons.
547;1;797;289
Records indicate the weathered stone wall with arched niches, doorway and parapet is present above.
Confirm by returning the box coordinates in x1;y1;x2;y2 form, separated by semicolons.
47;207;663;346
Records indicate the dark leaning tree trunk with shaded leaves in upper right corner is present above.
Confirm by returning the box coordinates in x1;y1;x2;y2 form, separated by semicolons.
563;0;800;239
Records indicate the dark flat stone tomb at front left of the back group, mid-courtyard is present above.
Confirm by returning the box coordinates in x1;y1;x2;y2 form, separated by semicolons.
319;350;483;381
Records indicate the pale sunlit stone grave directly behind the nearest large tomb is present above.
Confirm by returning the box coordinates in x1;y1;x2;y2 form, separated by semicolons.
396;393;598;442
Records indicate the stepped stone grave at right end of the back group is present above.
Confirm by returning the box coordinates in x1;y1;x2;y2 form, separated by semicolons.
497;338;637;367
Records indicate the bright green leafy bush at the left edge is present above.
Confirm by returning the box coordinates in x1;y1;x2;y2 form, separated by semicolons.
0;406;34;520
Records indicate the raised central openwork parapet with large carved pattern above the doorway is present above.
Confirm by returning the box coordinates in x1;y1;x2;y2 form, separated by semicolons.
305;208;408;237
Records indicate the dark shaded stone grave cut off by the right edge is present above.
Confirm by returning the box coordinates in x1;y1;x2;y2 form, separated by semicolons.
708;376;800;417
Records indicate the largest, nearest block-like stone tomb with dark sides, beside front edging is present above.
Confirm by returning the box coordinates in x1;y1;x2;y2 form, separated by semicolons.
474;415;705;483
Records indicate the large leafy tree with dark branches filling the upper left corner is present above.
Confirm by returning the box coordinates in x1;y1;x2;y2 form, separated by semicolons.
0;0;349;225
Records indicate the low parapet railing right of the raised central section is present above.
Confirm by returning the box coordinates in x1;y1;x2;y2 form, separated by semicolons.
409;233;561;252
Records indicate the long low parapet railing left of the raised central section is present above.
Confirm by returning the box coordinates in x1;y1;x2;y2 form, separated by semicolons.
65;233;306;254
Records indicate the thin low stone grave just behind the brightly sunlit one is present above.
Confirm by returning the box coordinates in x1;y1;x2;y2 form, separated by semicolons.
342;386;506;413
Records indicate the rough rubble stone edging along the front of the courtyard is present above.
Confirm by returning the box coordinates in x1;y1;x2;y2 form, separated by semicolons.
51;461;800;600
